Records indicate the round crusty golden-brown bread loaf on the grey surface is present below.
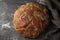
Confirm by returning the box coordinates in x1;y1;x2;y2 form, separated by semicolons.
13;2;49;38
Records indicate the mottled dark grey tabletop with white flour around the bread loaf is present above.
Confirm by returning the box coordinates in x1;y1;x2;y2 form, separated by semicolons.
0;0;60;40
